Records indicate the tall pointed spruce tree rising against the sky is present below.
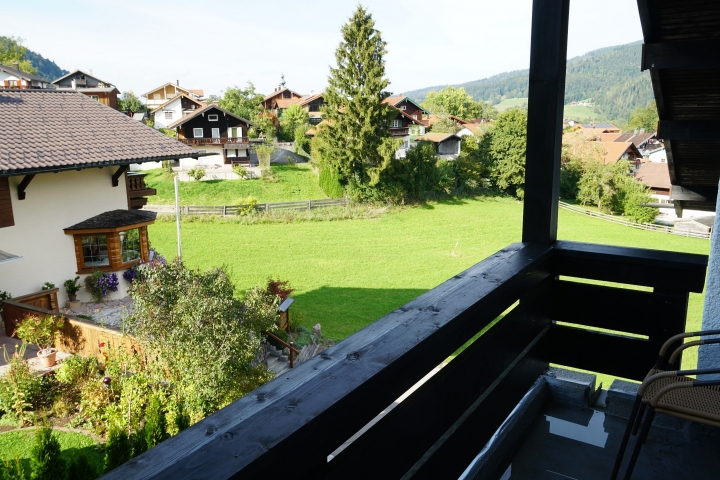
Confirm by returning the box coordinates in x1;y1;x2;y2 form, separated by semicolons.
317;6;397;189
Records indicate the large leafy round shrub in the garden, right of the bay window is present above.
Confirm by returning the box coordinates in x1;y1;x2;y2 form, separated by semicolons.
124;262;277;420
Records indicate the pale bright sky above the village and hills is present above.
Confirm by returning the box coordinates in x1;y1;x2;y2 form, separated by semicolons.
0;0;642;98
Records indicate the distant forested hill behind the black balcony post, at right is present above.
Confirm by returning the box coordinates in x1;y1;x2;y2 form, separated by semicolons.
405;42;653;120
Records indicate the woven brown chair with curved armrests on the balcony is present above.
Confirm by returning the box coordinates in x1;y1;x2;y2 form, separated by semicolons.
610;330;720;480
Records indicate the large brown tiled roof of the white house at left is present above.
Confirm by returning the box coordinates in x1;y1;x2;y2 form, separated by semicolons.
0;89;204;176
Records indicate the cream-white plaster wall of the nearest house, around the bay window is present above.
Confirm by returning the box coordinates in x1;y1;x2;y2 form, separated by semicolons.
0;167;134;305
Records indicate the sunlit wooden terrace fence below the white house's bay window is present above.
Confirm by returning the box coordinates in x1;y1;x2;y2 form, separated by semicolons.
2;296;140;362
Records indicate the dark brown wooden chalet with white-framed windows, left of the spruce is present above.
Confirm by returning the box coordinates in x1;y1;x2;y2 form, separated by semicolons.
167;105;255;166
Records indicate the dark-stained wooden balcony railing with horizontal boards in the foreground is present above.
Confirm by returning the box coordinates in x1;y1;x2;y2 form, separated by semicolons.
102;242;707;480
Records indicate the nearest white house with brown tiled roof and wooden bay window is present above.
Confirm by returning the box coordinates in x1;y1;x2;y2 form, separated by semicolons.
0;89;208;304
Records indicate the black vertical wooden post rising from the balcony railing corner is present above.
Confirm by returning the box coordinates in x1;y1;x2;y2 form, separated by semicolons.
522;0;570;244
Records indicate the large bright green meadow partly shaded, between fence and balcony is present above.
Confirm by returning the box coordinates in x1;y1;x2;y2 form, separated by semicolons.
149;198;710;346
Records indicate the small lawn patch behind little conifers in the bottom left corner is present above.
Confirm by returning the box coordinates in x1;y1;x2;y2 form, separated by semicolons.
0;430;104;478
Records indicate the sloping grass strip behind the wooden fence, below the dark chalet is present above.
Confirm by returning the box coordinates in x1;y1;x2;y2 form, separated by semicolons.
145;164;328;205
